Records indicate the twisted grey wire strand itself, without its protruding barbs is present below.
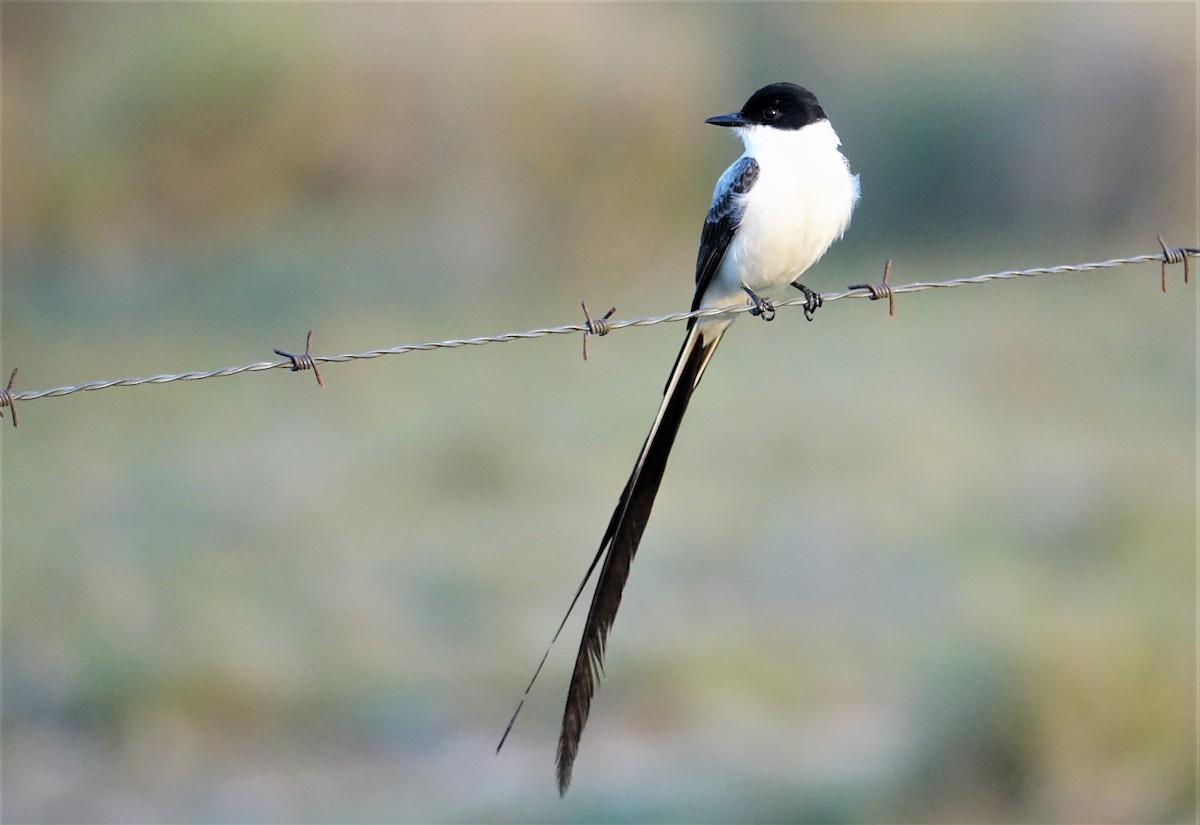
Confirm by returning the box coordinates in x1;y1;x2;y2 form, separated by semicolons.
7;246;1200;404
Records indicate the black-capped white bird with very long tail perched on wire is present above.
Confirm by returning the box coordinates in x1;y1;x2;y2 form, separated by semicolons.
502;83;859;794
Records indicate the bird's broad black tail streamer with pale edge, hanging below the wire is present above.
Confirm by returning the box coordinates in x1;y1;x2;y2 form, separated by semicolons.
557;321;728;795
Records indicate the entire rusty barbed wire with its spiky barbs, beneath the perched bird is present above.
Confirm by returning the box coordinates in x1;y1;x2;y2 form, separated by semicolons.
0;242;1200;426
